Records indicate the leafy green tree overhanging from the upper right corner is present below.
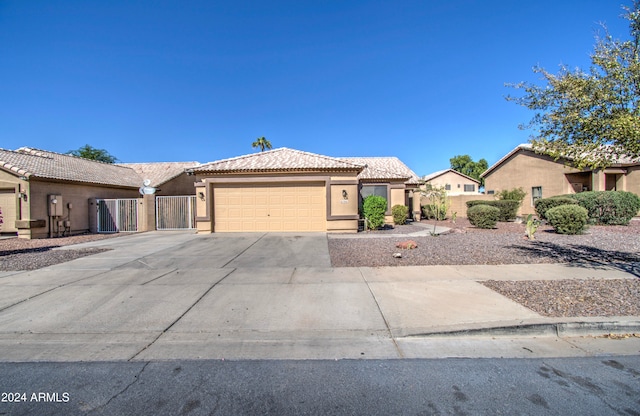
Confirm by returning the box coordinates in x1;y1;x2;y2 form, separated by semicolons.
506;0;640;169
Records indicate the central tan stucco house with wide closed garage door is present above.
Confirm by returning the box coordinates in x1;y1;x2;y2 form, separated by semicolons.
193;148;415;232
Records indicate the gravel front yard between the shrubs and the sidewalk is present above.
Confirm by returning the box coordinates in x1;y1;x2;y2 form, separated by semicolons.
329;218;640;267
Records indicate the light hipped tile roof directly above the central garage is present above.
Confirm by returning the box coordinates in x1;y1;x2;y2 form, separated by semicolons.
193;147;363;173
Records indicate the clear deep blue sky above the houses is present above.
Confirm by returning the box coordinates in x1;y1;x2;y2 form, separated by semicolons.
0;0;631;175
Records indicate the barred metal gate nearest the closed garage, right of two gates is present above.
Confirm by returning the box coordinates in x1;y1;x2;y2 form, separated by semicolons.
156;195;196;230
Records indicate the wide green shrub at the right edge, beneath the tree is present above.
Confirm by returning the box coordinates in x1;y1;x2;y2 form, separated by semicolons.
570;191;640;225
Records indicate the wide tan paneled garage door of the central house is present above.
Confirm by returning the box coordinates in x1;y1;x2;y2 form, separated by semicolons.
213;184;327;232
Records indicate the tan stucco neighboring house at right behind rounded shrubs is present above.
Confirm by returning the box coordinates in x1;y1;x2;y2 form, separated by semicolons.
481;144;640;215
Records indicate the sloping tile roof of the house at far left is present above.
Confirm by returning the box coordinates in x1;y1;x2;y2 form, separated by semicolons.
0;147;142;188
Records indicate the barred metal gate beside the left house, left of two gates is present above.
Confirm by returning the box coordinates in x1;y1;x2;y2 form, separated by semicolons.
98;198;138;233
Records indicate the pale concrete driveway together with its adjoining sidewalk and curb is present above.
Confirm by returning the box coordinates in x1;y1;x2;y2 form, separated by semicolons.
0;232;640;361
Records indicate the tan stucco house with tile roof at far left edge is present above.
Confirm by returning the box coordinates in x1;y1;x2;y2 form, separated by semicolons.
0;147;142;238
